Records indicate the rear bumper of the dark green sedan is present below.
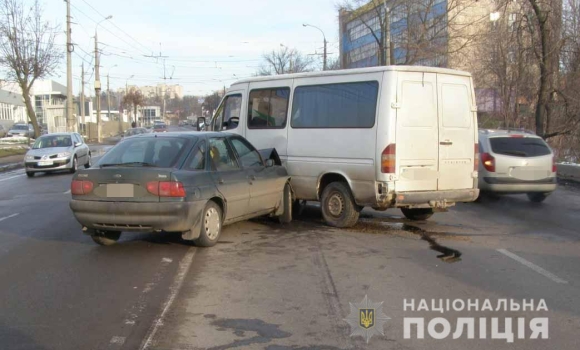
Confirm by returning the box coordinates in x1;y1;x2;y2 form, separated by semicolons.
70;199;205;238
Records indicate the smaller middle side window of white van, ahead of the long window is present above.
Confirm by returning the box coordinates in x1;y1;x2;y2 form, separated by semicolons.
248;88;290;129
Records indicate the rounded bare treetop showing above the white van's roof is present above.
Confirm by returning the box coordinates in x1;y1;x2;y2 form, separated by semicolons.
257;46;313;75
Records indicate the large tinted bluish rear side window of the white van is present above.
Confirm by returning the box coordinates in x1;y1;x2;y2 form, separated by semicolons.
291;81;379;128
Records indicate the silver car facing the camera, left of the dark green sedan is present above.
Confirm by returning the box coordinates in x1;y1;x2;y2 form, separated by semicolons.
24;132;91;177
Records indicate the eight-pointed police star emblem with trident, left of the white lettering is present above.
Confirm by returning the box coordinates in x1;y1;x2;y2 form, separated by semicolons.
344;295;391;343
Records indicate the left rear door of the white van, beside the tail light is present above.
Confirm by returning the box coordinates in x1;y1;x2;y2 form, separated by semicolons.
395;72;439;192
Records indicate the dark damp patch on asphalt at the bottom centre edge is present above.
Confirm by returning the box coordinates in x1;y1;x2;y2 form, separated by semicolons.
209;319;292;350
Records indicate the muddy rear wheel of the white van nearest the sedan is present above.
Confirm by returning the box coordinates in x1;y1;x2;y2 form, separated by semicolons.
320;182;359;227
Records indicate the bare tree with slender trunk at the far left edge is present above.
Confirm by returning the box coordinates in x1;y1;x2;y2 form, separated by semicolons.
0;0;62;137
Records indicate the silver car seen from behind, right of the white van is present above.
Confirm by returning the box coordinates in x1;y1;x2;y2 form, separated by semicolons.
479;129;557;202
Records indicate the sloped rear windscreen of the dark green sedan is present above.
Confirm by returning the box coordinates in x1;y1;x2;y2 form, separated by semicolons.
99;137;196;168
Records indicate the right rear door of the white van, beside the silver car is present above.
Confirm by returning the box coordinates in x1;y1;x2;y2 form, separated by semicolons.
437;74;477;190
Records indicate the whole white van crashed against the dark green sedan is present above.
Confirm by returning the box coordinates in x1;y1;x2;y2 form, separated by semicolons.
202;66;479;227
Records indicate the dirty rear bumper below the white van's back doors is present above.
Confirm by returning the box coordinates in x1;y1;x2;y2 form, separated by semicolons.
395;188;479;208
